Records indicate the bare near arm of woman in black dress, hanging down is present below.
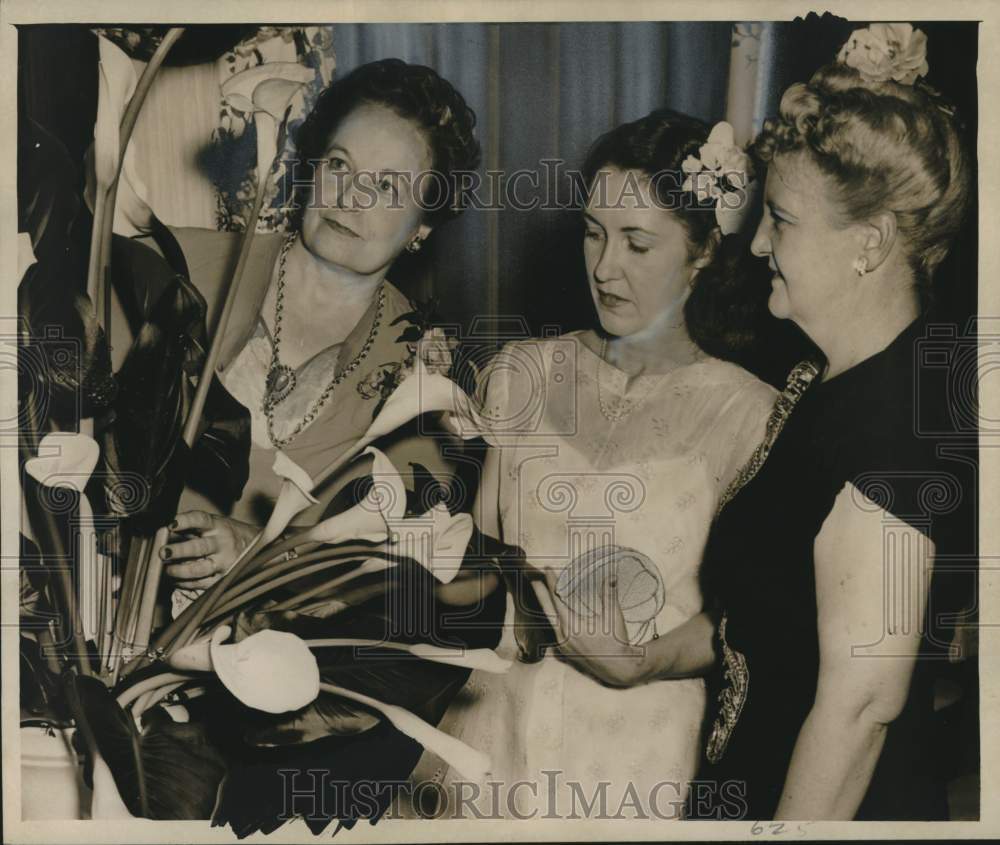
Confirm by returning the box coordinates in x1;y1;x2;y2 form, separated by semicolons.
775;484;934;819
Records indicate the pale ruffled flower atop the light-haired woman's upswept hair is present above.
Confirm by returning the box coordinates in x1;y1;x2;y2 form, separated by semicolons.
837;23;928;85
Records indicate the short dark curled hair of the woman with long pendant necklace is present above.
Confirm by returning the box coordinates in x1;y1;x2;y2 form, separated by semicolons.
296;59;480;226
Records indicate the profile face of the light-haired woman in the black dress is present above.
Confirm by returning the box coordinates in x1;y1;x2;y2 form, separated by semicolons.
751;154;863;339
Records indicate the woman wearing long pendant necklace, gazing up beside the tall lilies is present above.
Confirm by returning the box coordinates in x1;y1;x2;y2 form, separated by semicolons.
149;59;488;595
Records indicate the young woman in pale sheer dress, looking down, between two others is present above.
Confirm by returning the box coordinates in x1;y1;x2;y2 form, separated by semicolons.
414;105;774;818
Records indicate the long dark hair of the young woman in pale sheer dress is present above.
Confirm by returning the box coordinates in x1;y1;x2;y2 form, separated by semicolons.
582;109;763;360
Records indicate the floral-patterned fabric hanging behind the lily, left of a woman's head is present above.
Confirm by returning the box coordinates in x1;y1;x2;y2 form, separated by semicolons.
212;26;336;232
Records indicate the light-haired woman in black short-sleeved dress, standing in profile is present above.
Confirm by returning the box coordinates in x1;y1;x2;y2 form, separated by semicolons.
552;24;969;820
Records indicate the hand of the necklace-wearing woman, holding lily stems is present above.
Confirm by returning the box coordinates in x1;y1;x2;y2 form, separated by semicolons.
160;511;260;590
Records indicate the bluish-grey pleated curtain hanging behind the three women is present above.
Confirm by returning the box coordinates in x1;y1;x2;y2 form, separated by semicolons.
334;22;785;334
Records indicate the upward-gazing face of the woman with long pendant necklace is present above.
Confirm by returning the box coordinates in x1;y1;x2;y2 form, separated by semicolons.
302;103;431;276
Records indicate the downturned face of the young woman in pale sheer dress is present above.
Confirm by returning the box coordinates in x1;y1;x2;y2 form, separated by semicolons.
583;167;695;337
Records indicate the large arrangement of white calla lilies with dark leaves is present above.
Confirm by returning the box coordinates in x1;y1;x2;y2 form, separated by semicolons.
19;28;512;834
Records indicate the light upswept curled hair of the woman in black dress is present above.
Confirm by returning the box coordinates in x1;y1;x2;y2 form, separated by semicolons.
754;62;969;306
